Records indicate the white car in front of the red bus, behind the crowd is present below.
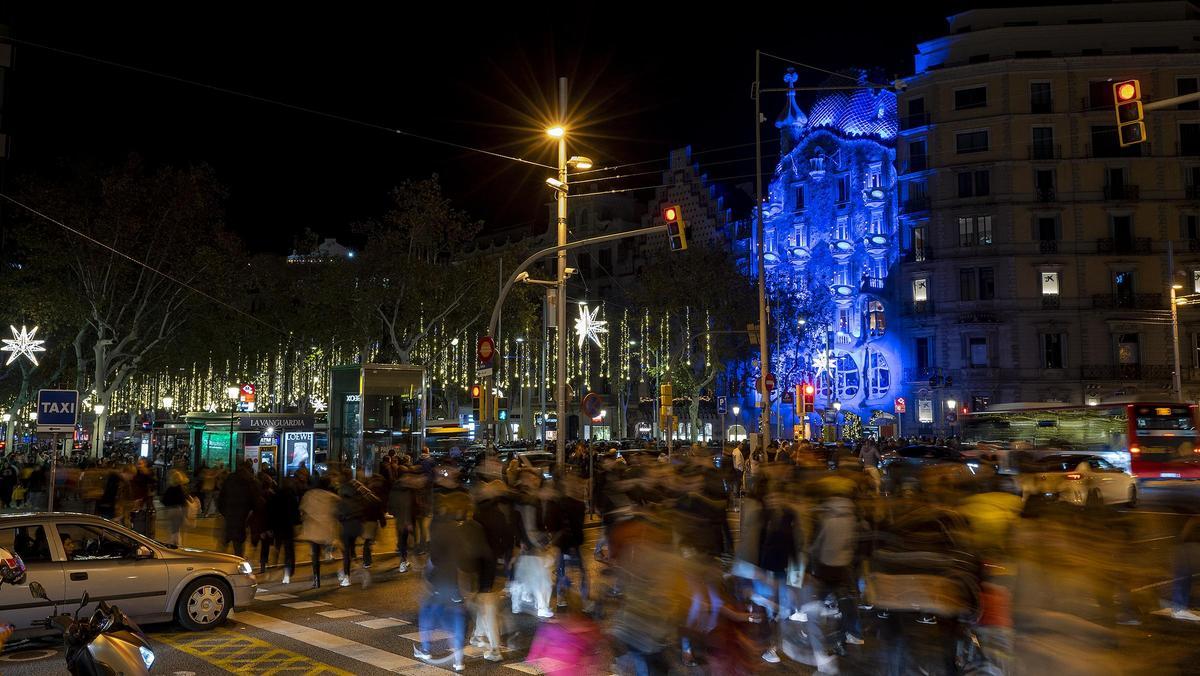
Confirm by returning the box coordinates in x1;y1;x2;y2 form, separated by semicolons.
1021;454;1138;507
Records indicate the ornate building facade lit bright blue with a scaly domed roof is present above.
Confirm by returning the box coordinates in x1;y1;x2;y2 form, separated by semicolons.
763;71;902;436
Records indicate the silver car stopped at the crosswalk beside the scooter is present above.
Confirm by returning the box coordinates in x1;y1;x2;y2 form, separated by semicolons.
0;513;258;635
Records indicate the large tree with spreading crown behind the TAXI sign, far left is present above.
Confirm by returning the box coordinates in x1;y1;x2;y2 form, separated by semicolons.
14;157;232;454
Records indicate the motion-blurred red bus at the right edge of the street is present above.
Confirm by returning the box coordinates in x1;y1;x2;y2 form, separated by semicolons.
962;401;1200;479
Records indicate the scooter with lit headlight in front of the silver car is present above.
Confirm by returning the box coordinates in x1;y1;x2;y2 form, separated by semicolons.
29;582;155;676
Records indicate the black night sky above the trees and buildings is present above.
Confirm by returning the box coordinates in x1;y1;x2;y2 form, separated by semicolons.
4;2;959;252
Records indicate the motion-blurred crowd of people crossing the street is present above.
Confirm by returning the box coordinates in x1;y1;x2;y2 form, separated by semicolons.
0;439;1200;675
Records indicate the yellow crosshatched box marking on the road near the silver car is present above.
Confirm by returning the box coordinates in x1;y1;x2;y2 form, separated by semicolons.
157;629;354;676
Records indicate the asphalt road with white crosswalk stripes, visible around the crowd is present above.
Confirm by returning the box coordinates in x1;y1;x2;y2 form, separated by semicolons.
7;485;1200;676
